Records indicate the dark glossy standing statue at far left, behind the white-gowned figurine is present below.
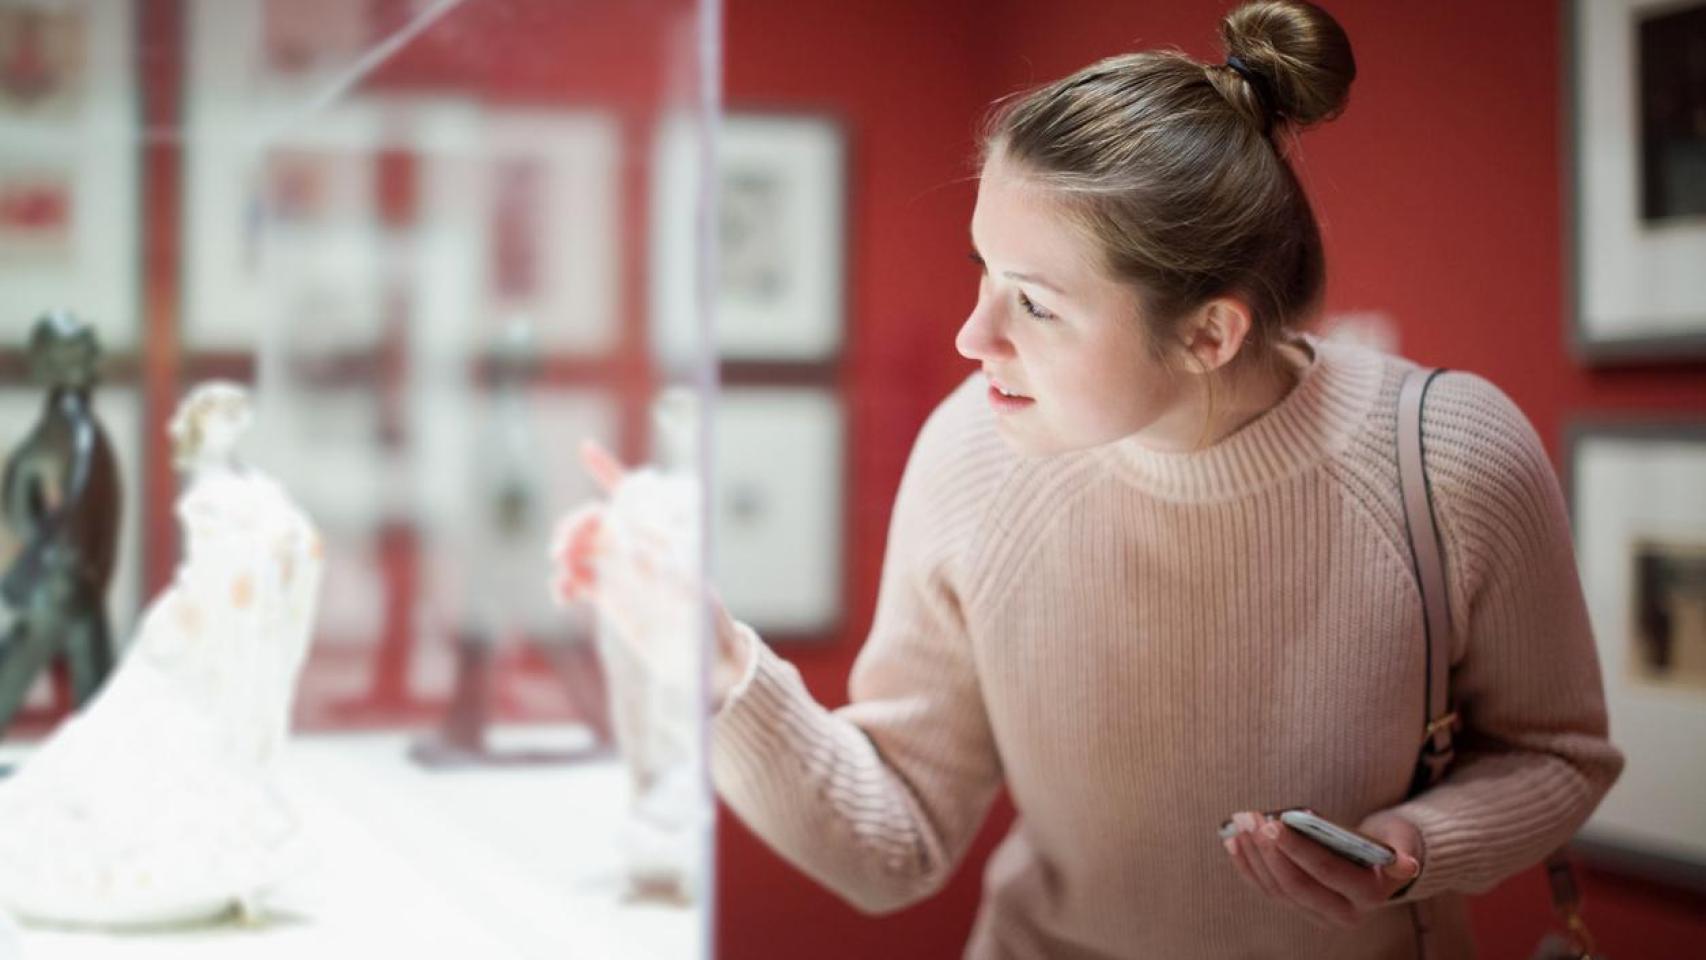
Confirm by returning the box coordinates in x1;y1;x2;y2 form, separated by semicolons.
0;310;119;733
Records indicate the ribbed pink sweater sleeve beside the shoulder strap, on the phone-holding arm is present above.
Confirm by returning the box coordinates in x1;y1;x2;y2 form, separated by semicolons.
1397;373;1622;900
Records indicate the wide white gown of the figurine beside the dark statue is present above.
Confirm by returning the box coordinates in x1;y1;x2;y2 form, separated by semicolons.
0;409;322;926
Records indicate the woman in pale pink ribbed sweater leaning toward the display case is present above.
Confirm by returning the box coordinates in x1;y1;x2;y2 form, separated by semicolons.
568;2;1622;960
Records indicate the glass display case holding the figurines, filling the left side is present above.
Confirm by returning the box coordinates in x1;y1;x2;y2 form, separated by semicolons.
0;0;718;960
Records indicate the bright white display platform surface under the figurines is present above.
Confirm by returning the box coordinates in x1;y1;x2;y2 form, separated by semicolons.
0;728;708;960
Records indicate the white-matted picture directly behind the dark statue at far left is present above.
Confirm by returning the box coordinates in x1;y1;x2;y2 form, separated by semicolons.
0;384;143;645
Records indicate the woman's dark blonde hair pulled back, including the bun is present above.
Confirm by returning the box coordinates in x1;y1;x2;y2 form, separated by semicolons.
983;0;1356;421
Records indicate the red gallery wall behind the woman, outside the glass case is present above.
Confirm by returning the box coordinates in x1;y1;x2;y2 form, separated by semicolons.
718;0;1706;960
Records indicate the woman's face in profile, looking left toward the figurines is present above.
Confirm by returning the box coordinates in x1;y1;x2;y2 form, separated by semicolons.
954;155;1199;454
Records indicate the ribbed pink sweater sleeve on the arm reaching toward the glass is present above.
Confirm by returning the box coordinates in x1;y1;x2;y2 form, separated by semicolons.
711;380;1001;912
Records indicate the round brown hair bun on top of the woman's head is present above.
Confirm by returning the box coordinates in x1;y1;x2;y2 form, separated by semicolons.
1220;0;1356;126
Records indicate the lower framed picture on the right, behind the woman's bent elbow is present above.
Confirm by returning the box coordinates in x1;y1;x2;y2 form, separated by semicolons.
1570;421;1706;888
